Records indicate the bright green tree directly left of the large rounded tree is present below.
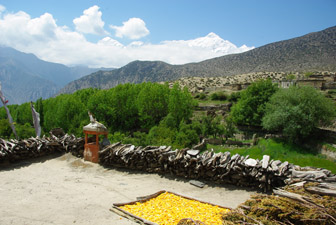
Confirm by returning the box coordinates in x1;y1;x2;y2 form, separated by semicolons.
231;80;278;126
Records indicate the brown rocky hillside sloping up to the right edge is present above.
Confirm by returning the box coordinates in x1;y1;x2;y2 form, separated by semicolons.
61;26;336;93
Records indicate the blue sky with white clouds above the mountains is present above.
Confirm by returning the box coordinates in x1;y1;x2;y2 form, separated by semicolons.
0;0;336;68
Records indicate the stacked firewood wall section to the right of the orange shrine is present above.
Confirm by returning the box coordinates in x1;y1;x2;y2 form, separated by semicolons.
100;143;336;191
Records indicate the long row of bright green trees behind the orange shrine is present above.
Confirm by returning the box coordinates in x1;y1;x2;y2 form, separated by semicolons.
0;82;195;138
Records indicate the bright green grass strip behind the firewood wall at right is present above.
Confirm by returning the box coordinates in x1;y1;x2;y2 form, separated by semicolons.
208;139;336;174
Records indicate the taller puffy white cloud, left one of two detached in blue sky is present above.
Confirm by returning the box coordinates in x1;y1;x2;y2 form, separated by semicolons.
73;5;108;35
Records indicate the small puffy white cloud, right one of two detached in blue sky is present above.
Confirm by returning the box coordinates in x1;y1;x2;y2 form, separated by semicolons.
110;18;149;40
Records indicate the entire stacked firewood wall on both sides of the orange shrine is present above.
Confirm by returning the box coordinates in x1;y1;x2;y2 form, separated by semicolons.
0;134;336;191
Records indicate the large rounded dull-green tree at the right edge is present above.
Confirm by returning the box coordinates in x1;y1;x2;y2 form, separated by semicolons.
262;86;336;141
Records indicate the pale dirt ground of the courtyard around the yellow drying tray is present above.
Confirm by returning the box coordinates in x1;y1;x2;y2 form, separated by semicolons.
0;154;255;225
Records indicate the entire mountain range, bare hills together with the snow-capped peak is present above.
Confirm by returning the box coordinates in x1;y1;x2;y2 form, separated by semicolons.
0;26;336;104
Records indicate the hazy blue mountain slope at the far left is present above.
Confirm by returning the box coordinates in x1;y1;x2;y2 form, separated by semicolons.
0;47;111;104
